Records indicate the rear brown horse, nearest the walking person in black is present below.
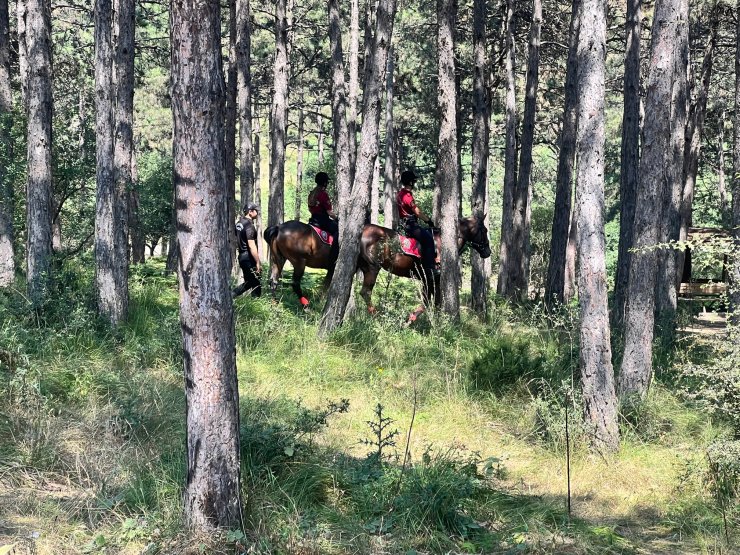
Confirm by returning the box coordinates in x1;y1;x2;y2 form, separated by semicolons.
263;220;337;307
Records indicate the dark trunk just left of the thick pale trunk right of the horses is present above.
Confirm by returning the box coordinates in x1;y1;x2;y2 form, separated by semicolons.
545;0;580;303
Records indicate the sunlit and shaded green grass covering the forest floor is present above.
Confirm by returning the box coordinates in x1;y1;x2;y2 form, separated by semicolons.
0;262;740;554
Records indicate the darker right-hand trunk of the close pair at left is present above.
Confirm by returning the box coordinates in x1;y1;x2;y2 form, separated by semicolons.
113;0;136;312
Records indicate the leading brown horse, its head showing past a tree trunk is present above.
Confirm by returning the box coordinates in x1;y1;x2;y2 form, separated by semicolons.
357;216;491;320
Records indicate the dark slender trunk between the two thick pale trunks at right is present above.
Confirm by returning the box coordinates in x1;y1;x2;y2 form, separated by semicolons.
613;0;642;325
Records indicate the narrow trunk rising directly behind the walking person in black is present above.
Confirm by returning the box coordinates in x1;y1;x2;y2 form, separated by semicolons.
241;0;260;205
